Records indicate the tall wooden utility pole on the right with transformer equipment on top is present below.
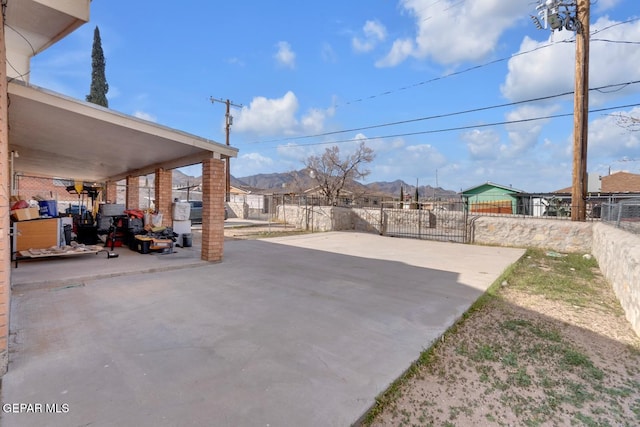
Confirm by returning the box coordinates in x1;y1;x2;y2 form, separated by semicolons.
531;0;591;221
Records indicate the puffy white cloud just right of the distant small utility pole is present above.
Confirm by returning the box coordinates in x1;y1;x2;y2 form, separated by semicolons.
233;91;298;135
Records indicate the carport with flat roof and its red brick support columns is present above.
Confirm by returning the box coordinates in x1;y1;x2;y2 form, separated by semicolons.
8;81;237;261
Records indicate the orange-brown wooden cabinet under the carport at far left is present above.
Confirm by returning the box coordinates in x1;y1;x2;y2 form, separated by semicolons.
13;218;60;252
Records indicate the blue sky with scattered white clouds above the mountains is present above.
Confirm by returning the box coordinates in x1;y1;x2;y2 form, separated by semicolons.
30;0;640;192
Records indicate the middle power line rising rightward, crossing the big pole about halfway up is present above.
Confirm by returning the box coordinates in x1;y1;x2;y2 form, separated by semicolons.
252;80;640;144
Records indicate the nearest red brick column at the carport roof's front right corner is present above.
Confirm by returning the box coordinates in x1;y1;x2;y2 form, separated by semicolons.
201;159;226;261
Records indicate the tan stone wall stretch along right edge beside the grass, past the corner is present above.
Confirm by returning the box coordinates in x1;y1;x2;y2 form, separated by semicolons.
592;223;640;335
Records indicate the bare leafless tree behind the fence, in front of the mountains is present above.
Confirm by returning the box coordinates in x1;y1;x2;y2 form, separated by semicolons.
304;141;375;205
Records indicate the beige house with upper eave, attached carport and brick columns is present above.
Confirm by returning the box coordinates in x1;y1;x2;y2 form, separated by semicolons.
0;0;238;375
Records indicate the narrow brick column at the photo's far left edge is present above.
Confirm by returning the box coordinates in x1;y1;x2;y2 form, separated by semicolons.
0;20;11;377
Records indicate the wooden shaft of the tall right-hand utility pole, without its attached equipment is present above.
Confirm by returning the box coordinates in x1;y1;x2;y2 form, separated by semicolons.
571;0;590;221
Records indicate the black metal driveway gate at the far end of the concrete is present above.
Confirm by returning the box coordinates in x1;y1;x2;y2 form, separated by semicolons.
380;201;469;243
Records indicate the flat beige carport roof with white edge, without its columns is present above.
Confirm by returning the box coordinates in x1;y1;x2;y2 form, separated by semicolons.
8;81;238;182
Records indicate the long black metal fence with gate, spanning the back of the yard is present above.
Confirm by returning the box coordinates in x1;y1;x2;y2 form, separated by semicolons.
228;194;640;243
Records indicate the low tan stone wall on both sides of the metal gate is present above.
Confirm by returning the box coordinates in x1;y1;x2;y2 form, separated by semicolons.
278;206;640;335
